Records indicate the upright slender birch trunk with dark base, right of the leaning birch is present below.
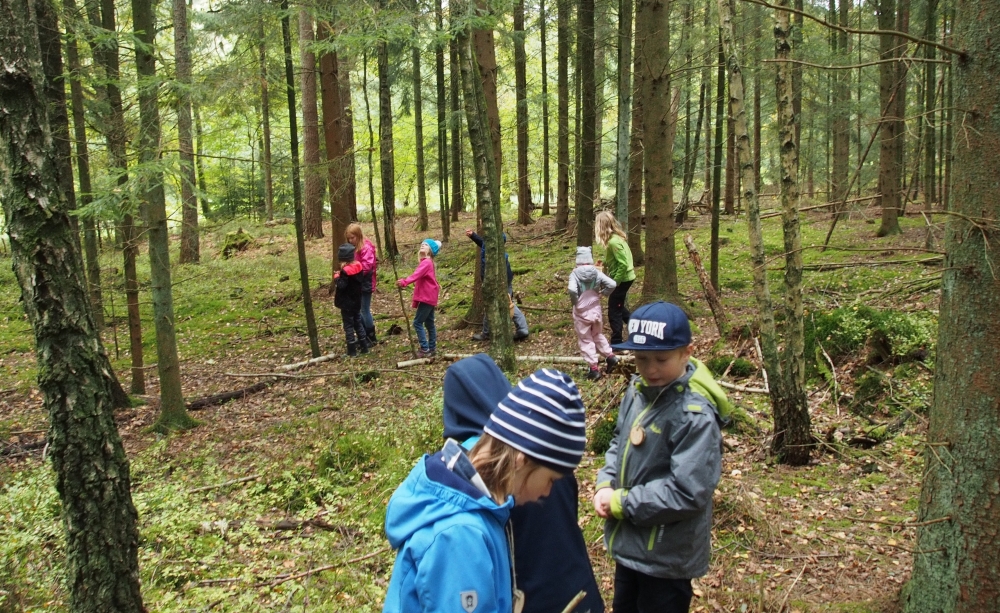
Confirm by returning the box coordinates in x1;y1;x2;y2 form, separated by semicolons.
771;0;812;466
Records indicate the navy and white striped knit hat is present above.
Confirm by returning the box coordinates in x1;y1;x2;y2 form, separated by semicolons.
484;368;587;473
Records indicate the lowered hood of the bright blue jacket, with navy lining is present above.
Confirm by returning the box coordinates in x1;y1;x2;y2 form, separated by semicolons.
385;453;514;549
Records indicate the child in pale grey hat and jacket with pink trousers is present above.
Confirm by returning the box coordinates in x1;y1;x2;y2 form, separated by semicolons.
569;247;618;381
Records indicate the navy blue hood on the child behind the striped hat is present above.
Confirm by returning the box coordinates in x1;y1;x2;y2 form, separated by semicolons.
443;353;510;442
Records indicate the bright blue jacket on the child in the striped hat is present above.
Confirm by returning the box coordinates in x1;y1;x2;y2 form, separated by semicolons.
382;441;514;613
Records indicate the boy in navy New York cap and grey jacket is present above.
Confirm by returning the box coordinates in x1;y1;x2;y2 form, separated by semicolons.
594;302;729;613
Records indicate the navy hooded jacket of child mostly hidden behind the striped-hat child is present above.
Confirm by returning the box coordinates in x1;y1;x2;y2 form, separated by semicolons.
443;353;604;613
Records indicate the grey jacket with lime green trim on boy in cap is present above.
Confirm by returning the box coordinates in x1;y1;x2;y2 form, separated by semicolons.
597;360;728;579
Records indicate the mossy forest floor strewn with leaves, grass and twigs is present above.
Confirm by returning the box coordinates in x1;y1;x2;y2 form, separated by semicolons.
0;198;940;613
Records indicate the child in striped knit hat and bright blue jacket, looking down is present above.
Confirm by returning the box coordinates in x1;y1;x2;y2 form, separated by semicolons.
382;369;586;613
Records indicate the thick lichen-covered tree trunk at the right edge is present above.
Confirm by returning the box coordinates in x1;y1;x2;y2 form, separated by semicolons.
903;0;1000;613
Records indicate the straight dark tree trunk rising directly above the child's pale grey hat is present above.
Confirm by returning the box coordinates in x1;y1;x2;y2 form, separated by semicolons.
576;0;596;246
